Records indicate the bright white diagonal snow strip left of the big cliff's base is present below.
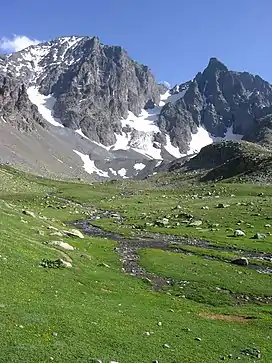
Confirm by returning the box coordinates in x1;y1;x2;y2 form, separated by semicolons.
27;86;64;127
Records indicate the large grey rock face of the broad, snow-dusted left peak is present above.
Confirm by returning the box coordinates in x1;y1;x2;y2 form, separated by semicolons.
0;37;160;145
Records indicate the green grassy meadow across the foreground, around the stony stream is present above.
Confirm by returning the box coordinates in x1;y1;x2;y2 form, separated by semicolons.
0;169;272;363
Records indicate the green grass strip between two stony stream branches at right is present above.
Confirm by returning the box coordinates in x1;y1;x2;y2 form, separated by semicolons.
140;249;272;306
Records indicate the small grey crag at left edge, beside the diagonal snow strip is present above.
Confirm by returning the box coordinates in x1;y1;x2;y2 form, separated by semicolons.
0;75;45;131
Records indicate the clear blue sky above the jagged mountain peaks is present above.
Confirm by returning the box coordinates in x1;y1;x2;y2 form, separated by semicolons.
0;0;272;84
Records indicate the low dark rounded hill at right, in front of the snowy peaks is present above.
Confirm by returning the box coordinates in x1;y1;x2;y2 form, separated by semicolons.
152;140;272;186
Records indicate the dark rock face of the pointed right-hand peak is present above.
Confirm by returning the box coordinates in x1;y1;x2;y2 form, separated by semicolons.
159;58;272;150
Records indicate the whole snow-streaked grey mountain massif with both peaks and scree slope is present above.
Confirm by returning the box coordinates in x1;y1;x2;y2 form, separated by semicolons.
0;36;272;180
